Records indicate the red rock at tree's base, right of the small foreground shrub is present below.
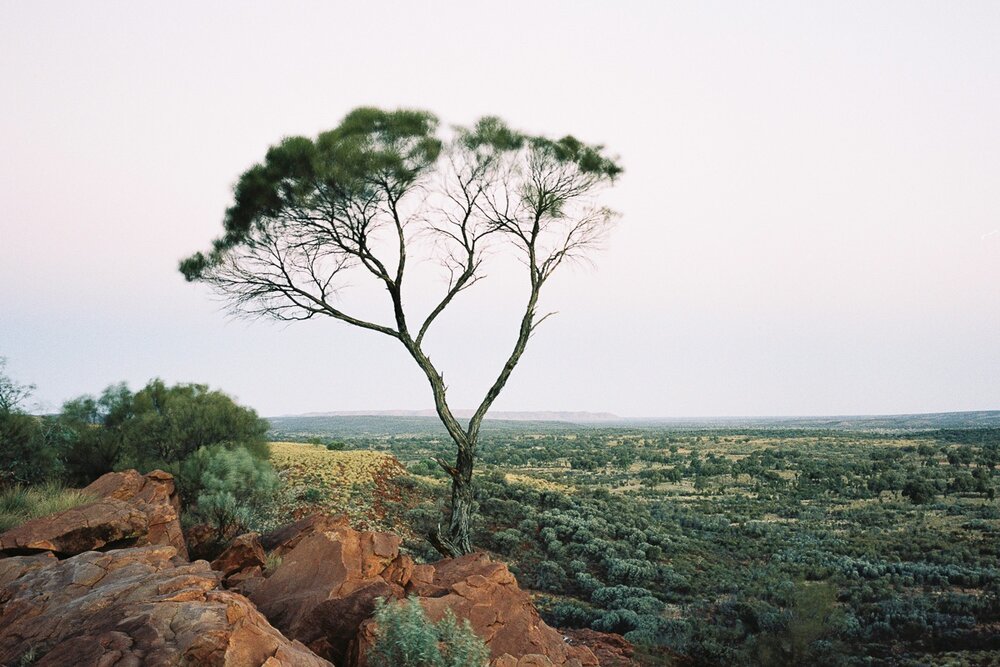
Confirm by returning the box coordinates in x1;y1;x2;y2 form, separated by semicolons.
348;553;599;667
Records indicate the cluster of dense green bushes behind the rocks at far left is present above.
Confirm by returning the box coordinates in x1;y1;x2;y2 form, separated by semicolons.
0;360;284;540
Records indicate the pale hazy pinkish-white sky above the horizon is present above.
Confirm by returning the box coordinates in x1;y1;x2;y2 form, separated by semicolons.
0;0;1000;416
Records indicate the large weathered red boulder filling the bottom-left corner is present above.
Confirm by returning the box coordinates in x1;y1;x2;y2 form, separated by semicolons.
0;546;330;667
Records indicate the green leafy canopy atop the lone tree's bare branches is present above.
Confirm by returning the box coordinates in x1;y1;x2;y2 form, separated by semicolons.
179;107;622;281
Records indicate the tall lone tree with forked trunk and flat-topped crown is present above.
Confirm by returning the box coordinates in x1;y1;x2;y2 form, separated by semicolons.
180;108;622;555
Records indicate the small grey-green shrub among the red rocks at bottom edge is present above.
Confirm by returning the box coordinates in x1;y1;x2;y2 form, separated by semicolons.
368;598;490;667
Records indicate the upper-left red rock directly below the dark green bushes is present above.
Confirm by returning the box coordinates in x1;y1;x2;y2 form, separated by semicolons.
0;470;187;558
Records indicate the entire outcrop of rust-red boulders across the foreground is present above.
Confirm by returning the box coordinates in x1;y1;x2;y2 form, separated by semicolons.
0;486;608;667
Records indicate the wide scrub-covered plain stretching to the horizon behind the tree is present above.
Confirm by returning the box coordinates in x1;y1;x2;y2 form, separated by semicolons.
279;418;1000;665
